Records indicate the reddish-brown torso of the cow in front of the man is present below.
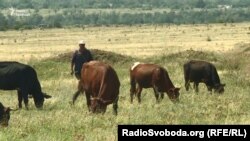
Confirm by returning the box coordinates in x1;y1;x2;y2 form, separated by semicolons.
81;61;120;104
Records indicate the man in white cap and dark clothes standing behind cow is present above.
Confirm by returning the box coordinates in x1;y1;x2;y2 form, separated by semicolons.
71;40;93;80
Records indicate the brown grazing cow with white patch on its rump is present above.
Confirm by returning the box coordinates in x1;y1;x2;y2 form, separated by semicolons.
130;62;180;103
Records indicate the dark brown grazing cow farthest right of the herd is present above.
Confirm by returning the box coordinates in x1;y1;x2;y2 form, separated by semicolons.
183;60;225;93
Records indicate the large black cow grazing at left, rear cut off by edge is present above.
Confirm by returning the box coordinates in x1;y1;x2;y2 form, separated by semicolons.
0;61;51;109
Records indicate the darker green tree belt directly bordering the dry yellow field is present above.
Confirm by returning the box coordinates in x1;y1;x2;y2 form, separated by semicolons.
0;9;250;30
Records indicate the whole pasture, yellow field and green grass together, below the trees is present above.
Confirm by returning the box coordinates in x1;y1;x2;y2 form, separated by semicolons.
0;23;250;141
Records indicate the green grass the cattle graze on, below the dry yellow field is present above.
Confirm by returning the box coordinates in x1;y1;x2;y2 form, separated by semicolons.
0;43;250;141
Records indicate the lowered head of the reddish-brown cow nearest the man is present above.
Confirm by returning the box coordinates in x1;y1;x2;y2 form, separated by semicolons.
90;98;107;113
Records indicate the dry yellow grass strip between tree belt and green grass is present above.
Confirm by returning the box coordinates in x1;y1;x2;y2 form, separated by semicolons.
0;23;250;62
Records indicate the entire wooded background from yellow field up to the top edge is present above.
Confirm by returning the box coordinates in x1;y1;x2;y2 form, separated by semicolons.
0;0;250;30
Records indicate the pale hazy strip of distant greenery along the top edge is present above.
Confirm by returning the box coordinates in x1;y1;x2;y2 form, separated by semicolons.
0;0;250;9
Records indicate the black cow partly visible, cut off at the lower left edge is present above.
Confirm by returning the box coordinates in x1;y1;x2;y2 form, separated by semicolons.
0;102;11;126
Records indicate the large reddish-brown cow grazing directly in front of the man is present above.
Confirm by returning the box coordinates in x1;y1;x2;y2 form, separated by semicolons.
73;60;120;115
